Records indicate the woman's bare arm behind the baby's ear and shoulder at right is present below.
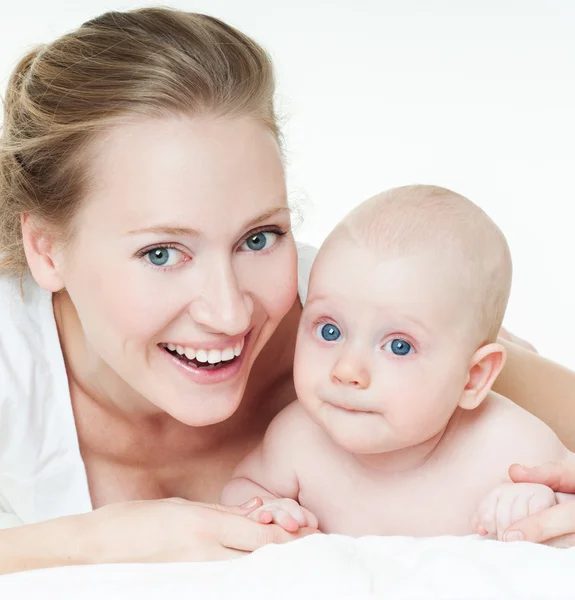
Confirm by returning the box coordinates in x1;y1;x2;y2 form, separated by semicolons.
493;340;575;451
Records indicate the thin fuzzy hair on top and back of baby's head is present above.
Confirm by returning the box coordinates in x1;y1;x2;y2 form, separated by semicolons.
340;185;512;345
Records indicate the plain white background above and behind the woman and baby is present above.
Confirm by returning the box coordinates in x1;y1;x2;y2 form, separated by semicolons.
0;0;575;368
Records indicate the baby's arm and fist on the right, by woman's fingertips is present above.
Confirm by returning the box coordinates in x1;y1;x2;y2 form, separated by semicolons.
473;399;575;539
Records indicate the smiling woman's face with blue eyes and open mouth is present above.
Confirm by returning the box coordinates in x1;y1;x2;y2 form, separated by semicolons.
55;116;297;426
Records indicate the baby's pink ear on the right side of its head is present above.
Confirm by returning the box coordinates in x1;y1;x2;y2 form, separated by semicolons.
459;343;505;410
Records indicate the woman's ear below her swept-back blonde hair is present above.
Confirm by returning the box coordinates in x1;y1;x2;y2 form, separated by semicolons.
20;214;64;292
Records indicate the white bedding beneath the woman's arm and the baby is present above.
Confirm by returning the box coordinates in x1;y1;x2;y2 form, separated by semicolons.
0;535;575;600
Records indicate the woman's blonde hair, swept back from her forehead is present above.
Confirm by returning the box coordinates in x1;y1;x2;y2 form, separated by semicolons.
0;8;280;273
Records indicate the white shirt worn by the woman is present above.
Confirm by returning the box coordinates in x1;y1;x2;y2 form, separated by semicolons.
0;244;316;529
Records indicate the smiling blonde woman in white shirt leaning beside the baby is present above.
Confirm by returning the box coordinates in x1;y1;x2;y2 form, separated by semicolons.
0;8;572;572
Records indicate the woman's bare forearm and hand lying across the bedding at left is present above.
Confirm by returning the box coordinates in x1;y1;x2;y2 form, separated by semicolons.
0;498;316;573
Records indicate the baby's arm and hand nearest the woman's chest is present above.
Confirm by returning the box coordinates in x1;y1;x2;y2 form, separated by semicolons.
221;402;317;531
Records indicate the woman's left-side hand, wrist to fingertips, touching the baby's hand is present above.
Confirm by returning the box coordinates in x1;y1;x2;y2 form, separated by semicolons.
75;498;315;564
